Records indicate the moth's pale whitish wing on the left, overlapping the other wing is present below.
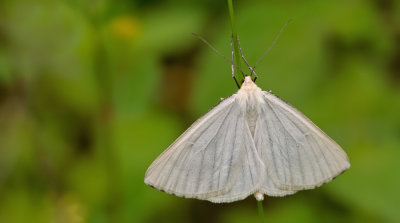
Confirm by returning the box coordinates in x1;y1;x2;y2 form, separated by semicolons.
145;95;265;202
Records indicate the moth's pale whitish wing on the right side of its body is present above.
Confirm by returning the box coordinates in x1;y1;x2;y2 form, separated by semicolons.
254;92;350;190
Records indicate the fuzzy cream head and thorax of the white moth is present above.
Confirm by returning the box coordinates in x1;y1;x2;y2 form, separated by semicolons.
237;76;265;137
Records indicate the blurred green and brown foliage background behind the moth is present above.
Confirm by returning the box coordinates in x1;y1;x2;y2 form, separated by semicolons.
0;0;400;223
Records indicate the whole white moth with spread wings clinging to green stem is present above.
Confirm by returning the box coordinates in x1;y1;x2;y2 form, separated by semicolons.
145;35;350;203
